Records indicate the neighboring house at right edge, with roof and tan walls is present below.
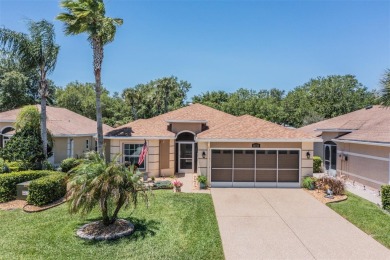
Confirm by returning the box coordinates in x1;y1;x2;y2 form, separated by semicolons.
300;106;390;188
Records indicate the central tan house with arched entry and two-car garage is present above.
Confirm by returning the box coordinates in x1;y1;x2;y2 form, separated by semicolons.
104;104;321;187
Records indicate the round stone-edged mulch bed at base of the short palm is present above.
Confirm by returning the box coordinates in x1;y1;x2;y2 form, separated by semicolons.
76;219;134;240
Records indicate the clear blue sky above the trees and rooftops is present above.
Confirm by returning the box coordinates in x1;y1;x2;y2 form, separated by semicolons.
0;0;390;97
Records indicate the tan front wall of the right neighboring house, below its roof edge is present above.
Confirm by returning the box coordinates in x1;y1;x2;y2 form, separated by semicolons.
337;143;390;189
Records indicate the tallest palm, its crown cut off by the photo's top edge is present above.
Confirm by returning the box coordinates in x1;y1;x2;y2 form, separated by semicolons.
57;0;123;156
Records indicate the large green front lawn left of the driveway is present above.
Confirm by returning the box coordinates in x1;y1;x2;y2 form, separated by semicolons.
0;190;224;259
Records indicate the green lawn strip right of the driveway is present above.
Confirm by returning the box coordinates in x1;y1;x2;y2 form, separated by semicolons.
327;192;390;249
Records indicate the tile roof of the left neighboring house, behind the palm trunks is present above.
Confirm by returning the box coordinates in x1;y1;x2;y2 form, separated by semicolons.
0;105;112;136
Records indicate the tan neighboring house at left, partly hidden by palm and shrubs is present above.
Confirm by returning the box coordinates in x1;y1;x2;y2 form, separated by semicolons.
0;105;112;165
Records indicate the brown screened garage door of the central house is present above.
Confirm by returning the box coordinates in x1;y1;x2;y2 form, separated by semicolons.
211;149;300;187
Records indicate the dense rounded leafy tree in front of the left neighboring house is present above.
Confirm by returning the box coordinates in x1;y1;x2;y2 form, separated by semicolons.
0;106;53;169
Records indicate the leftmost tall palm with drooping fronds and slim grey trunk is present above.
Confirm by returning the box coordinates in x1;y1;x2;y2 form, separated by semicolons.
0;20;60;165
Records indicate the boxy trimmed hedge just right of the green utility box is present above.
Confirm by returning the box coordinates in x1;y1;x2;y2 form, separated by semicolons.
27;173;66;206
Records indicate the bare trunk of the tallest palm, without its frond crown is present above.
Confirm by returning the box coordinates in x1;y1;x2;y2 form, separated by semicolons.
92;38;103;157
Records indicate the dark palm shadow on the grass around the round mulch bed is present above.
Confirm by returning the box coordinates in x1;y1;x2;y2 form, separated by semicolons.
80;218;160;245
